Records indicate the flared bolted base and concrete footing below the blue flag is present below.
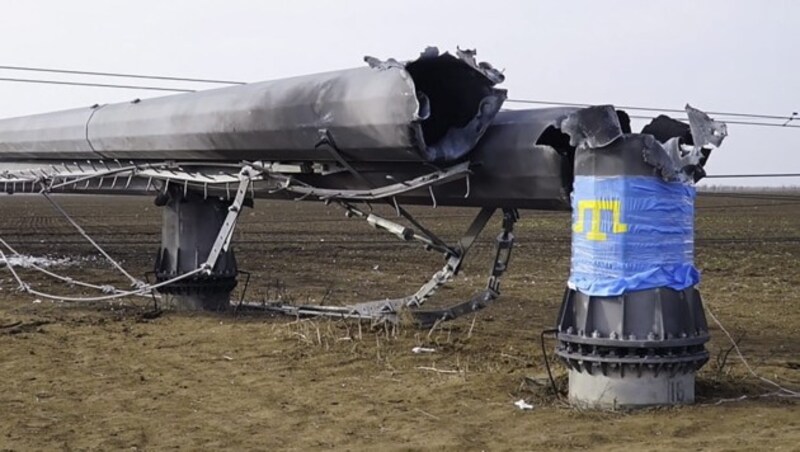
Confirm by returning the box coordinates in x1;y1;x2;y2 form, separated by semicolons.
556;288;709;408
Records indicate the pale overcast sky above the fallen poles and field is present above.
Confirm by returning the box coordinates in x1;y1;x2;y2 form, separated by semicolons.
0;0;800;184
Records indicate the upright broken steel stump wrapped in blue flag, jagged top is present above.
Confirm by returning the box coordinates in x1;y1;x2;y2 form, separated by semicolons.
557;106;726;408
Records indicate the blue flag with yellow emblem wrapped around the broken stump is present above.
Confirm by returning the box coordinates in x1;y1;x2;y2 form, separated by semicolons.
569;176;700;296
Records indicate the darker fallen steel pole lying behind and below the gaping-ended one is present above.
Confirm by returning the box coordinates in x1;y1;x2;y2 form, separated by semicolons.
0;108;576;210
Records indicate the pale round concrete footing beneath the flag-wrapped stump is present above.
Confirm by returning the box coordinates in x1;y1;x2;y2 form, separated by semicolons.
569;369;695;409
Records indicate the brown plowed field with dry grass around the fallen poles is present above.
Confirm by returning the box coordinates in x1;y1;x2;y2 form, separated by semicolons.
0;195;800;450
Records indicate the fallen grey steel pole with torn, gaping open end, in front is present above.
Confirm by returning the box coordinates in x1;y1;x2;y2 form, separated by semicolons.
0;49;505;163
